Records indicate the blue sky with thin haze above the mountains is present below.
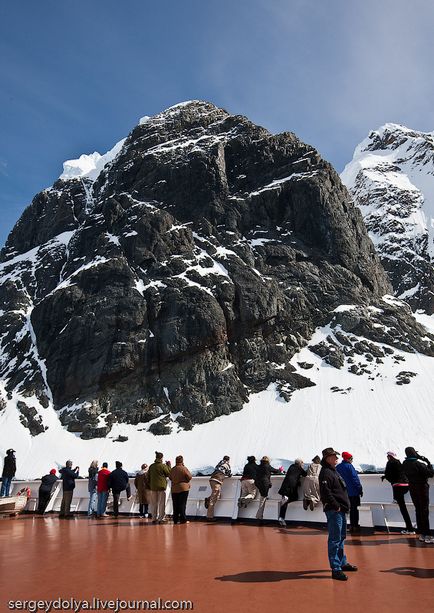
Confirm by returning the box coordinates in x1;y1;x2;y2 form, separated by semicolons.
0;0;434;245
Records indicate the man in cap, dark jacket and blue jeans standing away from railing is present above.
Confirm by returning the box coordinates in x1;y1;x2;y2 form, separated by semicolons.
319;447;357;581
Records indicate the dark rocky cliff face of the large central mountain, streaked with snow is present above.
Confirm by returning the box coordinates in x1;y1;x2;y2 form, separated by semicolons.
0;102;432;438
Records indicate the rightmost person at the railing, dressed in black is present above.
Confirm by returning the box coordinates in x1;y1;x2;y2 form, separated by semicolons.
402;447;434;545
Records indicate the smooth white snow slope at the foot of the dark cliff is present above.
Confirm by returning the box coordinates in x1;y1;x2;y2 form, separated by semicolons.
0;307;434;478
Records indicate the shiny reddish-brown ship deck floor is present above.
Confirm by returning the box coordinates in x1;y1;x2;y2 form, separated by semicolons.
0;515;434;613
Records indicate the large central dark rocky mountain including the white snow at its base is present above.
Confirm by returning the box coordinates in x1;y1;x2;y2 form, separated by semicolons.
0;101;434;477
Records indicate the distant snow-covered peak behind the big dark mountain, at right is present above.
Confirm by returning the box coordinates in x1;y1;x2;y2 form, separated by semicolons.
341;124;434;314
